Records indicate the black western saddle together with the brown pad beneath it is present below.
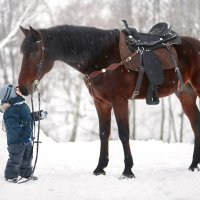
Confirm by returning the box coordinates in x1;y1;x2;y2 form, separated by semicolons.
119;20;182;105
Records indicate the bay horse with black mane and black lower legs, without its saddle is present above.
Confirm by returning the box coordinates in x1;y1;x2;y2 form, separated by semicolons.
18;25;200;178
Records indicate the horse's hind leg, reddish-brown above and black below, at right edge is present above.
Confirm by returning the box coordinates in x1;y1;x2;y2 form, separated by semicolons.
177;84;200;171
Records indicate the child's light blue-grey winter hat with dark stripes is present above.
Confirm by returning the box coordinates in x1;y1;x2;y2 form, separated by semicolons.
0;84;17;103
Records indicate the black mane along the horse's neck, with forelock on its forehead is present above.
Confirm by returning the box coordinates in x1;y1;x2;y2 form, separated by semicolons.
21;25;119;65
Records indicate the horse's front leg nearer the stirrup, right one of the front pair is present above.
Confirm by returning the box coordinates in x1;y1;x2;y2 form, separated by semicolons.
113;97;135;178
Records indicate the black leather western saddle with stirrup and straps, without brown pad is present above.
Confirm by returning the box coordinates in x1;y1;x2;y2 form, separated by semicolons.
120;20;181;105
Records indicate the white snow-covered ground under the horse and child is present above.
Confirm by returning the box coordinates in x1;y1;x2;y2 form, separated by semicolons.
0;133;200;200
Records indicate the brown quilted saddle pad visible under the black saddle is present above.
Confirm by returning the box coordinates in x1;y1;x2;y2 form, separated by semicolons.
119;32;178;71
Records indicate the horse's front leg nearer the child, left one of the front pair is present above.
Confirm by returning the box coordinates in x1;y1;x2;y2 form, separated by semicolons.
93;100;112;175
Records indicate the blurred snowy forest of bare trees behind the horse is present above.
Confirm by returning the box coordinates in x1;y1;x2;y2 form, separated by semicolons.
0;0;200;142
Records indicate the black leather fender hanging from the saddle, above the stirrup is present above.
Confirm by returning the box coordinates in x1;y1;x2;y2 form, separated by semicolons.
142;50;164;85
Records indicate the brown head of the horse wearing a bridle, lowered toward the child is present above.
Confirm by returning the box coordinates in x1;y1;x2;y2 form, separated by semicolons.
18;26;53;95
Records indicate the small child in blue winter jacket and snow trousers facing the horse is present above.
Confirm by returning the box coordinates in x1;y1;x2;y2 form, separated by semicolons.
0;84;47;182
